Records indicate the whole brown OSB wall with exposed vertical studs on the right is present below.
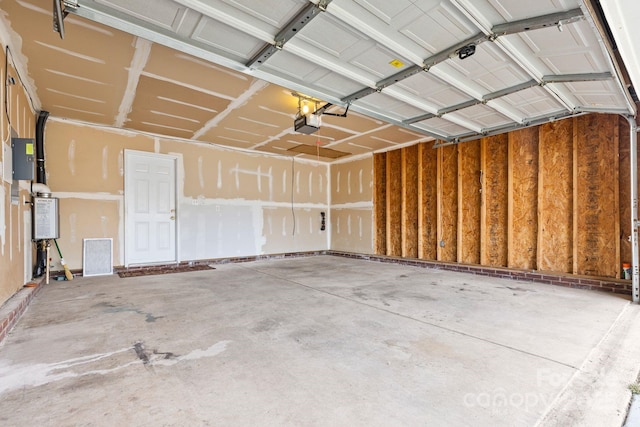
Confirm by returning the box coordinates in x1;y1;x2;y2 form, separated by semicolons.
373;114;630;278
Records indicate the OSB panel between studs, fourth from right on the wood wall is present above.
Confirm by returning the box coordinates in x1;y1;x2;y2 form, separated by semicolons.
508;128;539;270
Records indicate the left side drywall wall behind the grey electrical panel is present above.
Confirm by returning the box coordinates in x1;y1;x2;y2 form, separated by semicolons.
0;49;36;305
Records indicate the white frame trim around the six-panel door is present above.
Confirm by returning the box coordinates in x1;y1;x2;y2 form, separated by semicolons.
122;148;180;267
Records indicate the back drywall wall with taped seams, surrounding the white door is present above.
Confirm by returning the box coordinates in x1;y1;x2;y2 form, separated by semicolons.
45;118;330;269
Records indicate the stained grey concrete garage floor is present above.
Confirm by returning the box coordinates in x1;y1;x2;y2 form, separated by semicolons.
0;256;640;427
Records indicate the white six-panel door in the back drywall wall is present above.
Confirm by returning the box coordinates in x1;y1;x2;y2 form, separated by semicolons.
124;150;177;265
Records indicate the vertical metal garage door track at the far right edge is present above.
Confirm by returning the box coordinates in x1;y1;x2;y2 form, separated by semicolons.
627;116;640;303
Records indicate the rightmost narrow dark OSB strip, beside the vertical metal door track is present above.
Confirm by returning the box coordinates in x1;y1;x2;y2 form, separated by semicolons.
618;117;631;270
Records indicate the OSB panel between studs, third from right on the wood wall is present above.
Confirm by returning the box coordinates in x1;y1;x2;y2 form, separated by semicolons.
537;119;573;273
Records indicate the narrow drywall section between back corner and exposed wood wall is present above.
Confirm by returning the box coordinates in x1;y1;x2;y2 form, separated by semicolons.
330;156;376;253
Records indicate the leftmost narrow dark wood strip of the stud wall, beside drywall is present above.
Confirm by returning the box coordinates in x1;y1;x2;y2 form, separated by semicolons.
373;153;387;255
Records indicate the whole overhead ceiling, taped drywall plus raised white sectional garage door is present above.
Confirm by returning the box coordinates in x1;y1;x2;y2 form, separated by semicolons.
0;0;635;161
